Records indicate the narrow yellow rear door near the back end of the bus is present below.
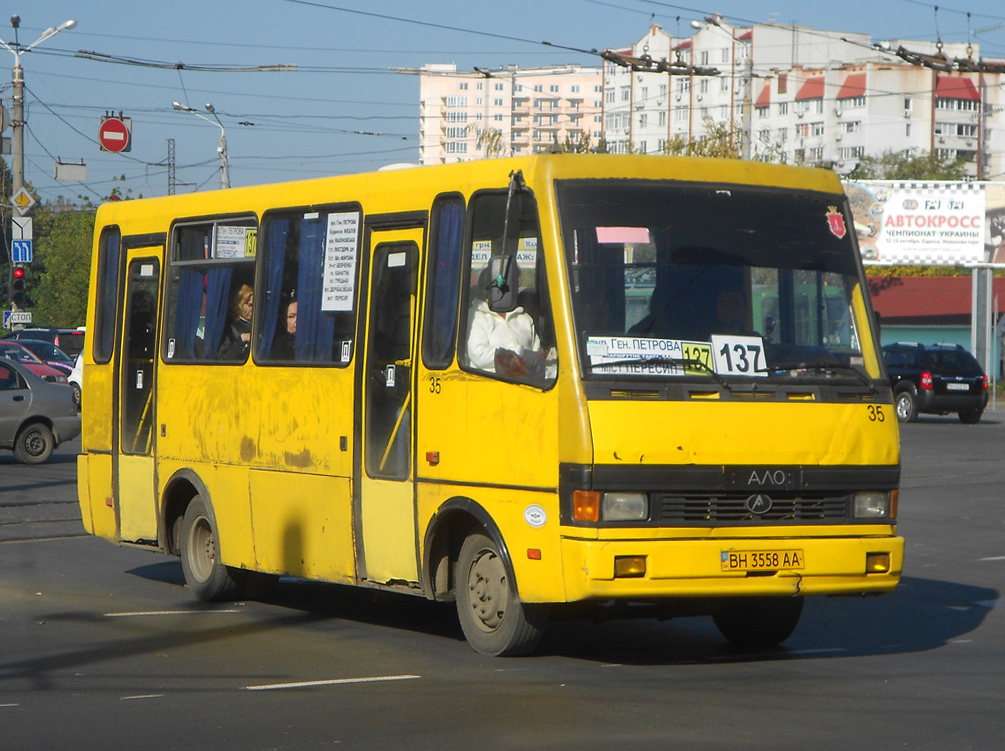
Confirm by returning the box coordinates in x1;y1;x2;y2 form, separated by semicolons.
113;255;162;542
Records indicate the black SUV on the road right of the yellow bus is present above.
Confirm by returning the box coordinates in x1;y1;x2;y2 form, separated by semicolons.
882;342;988;424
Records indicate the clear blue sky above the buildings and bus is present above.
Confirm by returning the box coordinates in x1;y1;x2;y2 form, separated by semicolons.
0;0;1005;203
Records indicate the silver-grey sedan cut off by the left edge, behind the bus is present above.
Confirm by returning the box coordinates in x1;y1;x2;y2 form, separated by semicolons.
0;359;80;464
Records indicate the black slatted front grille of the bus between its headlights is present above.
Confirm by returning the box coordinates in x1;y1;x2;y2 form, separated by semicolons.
653;495;851;526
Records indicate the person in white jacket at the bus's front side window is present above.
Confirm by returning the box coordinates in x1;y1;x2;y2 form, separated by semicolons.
467;256;544;378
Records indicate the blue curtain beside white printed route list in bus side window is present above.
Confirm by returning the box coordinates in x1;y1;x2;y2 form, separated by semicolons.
295;216;335;362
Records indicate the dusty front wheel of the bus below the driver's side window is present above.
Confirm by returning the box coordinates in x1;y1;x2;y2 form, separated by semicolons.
456;532;548;656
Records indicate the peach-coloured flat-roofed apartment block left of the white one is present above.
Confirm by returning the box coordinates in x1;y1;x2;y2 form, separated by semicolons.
419;64;603;164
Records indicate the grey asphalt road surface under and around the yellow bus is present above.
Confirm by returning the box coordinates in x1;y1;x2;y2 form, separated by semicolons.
0;412;1005;751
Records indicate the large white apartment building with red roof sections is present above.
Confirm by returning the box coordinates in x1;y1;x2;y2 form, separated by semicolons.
604;17;1005;179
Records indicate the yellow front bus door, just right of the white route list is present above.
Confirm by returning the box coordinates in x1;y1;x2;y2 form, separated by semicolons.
356;229;422;583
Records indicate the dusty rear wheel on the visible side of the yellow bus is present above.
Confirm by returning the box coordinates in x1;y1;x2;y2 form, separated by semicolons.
181;496;245;602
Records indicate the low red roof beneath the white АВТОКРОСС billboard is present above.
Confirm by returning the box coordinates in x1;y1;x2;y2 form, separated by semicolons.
868;276;1005;325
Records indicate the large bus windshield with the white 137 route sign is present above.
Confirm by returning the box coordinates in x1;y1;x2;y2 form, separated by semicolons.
557;180;879;383
